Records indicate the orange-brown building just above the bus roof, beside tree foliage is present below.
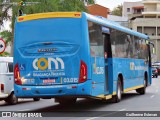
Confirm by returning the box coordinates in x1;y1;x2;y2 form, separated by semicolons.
87;4;109;18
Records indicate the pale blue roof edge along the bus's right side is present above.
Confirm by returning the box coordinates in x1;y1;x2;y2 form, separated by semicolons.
83;12;149;39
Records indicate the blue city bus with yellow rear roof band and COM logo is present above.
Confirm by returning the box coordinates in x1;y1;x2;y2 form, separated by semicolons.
14;12;151;104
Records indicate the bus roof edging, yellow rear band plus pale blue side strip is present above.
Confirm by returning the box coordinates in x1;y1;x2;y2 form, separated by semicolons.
17;12;149;39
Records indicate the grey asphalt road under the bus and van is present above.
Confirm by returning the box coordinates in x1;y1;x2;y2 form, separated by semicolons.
0;76;160;120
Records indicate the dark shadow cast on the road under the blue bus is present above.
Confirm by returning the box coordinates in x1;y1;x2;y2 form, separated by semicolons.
31;93;141;112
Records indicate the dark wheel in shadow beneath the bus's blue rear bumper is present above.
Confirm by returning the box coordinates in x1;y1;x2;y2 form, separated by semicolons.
55;98;77;105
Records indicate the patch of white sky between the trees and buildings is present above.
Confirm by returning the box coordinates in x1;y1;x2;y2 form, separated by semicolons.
96;0;142;10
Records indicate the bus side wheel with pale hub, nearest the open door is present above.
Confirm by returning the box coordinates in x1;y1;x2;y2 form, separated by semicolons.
112;78;122;103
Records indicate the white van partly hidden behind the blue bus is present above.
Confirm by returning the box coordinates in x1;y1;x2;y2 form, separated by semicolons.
0;57;40;104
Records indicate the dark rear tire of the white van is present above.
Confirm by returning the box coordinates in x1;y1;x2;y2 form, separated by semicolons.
5;92;18;105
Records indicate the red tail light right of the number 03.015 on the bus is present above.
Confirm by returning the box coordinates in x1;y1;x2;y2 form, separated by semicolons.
78;61;87;83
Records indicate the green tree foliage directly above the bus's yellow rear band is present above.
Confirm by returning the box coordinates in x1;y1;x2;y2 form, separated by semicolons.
12;0;87;30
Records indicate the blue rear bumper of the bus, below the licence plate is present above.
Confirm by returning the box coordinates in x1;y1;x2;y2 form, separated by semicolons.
14;80;91;98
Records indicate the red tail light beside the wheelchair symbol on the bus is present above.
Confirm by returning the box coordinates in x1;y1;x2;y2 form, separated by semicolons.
14;63;22;85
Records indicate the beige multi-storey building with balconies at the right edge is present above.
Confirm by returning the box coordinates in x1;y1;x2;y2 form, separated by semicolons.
124;0;160;61
